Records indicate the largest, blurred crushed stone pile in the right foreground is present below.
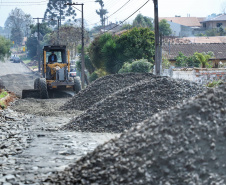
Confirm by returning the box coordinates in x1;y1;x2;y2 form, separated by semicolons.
44;84;226;185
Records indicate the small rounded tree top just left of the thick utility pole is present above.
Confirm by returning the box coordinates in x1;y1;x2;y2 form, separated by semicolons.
133;14;154;30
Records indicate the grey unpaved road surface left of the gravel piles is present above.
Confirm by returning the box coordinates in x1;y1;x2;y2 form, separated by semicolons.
0;61;119;184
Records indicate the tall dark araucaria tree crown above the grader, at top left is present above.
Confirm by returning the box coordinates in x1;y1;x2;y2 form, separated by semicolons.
44;0;76;25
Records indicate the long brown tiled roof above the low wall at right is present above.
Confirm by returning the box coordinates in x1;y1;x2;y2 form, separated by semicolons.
162;43;226;59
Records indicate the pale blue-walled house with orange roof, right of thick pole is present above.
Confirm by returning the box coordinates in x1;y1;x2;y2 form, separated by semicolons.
159;16;205;37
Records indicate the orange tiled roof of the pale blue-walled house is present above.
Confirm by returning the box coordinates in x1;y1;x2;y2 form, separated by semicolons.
159;17;205;27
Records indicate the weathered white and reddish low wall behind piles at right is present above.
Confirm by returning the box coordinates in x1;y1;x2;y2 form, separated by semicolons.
162;67;226;85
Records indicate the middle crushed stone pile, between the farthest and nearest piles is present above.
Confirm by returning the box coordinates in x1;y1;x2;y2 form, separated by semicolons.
63;76;203;133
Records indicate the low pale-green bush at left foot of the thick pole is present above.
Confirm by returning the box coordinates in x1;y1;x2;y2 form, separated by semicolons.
119;59;153;73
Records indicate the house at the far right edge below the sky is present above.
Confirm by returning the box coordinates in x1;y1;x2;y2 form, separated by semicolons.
201;14;226;29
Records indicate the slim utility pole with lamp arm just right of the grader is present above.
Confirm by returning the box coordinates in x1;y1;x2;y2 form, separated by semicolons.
64;3;85;89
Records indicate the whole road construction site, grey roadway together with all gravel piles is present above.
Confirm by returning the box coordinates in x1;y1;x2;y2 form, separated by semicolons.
0;61;226;185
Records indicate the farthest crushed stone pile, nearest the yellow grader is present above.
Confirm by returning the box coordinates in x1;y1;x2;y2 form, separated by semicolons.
61;73;157;110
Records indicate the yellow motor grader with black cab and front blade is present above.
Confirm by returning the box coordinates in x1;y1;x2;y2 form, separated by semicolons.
22;46;81;99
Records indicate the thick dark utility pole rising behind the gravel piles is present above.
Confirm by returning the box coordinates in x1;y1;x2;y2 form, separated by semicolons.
153;0;162;75
